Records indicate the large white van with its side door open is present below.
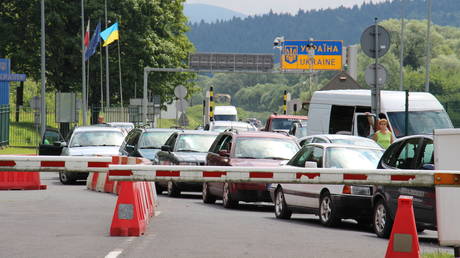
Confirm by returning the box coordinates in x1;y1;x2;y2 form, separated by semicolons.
308;90;453;137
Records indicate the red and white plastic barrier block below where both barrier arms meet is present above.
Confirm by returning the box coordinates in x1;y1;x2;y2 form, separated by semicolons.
110;182;154;236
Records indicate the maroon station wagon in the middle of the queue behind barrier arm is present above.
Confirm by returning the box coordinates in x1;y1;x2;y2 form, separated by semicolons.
203;130;300;208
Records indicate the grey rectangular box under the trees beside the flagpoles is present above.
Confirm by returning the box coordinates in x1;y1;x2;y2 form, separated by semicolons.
56;92;78;123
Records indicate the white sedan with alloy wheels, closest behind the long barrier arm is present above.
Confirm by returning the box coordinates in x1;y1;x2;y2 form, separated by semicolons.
269;143;384;226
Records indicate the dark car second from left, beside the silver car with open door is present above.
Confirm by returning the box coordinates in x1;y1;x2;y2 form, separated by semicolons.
120;128;178;164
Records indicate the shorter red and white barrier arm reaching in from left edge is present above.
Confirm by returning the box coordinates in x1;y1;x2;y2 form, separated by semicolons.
0;155;115;172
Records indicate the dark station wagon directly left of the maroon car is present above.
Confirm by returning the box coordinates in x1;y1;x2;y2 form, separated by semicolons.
157;130;218;197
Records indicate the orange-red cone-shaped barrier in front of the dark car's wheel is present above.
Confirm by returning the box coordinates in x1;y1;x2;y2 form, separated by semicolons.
385;195;420;258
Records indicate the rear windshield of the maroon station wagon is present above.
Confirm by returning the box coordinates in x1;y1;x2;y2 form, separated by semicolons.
235;137;299;160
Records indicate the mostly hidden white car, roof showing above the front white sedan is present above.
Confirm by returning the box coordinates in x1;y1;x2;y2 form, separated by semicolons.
298;134;380;148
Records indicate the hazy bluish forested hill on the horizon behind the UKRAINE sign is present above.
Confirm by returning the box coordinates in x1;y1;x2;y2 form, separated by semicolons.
187;0;460;53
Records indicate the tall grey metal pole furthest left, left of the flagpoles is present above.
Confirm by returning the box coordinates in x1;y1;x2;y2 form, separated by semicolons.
40;0;46;137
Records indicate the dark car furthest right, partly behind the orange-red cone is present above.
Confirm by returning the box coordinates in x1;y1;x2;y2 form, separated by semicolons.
373;135;436;238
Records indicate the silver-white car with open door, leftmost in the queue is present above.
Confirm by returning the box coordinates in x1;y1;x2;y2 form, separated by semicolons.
59;126;125;184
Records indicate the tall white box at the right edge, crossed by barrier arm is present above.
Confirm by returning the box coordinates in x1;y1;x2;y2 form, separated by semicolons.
434;128;460;247
